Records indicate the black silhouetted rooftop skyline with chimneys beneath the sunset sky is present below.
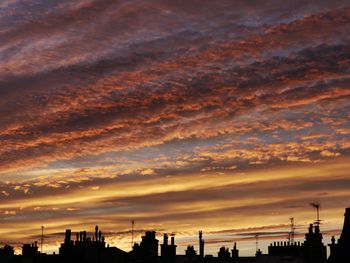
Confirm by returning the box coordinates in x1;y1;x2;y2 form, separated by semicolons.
0;207;350;263
